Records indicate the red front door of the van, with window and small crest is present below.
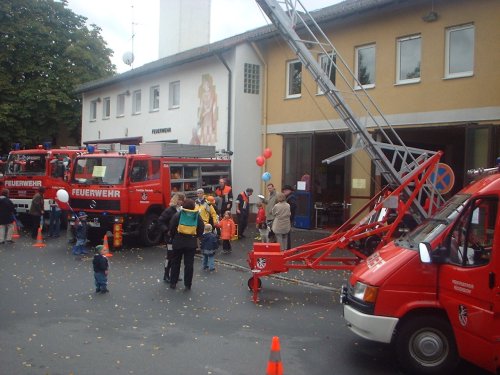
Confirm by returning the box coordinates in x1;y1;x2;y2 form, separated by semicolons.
438;197;500;371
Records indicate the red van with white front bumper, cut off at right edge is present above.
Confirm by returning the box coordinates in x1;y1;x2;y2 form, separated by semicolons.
341;164;500;374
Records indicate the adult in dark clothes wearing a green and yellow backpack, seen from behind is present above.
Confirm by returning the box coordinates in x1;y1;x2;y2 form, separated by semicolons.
170;199;205;290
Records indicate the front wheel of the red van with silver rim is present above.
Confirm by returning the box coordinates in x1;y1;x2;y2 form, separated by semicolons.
395;315;459;375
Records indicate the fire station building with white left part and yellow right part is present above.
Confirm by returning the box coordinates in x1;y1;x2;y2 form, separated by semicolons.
78;0;500;223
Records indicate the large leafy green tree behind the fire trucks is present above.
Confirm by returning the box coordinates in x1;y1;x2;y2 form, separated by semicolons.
0;0;115;152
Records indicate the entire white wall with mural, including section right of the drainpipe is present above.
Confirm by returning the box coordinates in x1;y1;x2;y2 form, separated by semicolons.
82;44;263;212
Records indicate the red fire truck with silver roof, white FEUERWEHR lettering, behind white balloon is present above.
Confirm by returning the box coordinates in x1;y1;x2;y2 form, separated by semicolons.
69;143;231;247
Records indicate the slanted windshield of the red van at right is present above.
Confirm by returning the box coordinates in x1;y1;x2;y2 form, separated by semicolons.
395;194;471;250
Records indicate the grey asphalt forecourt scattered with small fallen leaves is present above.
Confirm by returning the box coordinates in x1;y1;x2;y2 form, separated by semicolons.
0;226;484;375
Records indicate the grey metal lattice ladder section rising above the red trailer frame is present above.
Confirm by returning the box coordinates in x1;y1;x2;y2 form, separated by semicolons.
256;0;443;222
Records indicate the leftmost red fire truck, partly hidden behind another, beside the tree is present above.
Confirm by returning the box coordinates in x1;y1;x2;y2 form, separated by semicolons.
4;144;84;215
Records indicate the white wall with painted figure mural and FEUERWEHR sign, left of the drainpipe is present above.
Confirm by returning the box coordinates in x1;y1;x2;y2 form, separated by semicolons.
82;57;228;149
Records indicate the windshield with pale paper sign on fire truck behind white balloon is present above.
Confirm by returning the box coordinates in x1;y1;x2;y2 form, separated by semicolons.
71;156;126;185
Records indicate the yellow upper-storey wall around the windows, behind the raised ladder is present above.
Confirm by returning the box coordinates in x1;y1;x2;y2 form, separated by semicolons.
262;0;500;126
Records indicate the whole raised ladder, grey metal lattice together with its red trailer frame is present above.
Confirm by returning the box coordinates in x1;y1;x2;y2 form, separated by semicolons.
248;0;444;302
